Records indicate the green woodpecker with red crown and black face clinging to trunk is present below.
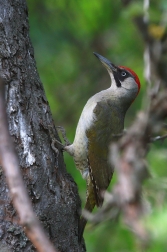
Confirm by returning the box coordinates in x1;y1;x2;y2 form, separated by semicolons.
64;53;140;239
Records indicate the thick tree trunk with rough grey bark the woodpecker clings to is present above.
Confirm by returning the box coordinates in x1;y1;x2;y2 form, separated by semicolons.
0;0;85;252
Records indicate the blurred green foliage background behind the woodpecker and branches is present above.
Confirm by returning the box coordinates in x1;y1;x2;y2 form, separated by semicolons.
27;0;167;252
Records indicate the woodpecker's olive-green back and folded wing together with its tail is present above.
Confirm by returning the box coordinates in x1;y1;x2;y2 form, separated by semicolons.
79;100;125;237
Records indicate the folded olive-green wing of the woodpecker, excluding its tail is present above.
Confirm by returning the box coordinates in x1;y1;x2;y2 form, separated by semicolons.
86;102;120;206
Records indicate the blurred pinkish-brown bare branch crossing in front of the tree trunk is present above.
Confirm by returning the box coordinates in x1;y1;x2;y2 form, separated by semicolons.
0;79;58;252
